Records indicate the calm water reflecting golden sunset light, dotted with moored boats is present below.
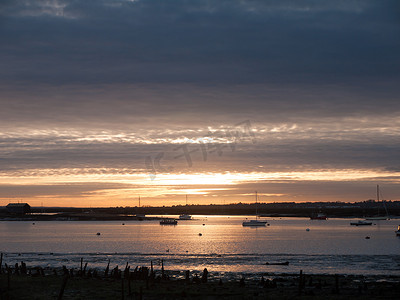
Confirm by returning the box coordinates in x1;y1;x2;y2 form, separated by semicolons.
0;216;400;276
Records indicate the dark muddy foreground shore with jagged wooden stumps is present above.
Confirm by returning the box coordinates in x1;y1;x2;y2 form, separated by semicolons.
0;268;400;300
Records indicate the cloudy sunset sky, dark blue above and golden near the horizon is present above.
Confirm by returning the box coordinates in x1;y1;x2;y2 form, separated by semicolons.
0;0;400;207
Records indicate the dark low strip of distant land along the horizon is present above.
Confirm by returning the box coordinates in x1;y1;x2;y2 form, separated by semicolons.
0;200;400;221
